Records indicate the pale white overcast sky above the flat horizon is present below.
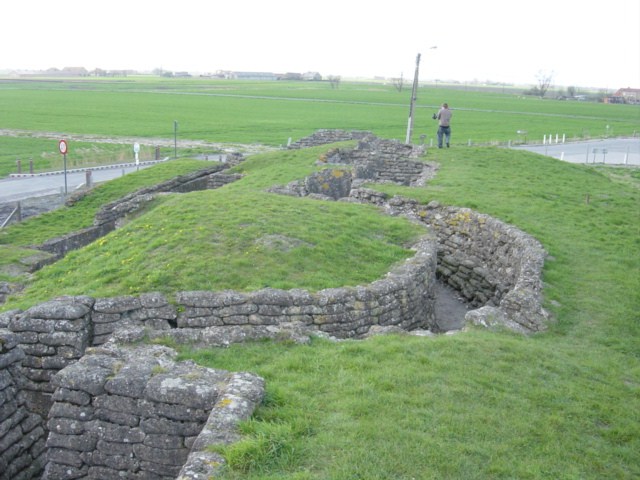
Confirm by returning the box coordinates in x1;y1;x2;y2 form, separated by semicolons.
0;0;640;89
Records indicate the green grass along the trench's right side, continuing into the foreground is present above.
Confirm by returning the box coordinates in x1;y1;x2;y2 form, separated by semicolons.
169;148;640;479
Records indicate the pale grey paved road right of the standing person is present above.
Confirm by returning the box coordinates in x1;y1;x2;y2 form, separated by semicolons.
513;138;640;166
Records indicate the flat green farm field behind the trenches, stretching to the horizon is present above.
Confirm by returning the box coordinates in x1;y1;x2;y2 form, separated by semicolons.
0;77;640;177
